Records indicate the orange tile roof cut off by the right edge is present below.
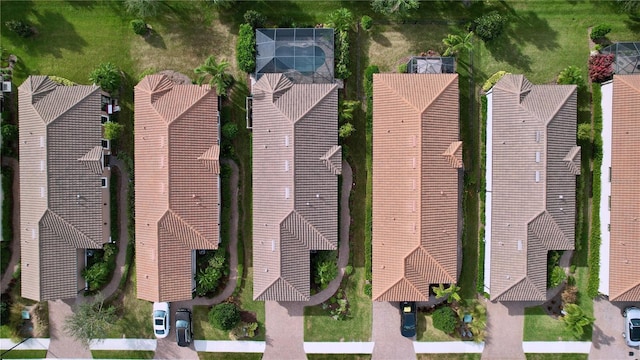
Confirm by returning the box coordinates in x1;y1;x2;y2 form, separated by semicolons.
609;75;640;301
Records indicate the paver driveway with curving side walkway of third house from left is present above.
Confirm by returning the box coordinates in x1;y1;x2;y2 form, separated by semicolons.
263;161;353;360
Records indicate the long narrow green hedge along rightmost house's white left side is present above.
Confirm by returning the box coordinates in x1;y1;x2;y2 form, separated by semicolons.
587;83;602;298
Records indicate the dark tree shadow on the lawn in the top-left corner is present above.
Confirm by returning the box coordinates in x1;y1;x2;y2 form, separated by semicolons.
31;10;88;58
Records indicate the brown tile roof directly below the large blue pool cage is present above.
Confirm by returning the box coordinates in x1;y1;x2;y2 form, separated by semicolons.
253;74;342;301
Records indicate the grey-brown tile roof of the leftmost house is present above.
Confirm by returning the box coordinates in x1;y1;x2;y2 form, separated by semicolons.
18;76;110;301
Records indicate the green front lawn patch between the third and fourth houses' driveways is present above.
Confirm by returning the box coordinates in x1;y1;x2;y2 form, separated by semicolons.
304;268;372;342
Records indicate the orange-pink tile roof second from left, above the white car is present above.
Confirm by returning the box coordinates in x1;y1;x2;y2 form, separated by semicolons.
134;75;220;301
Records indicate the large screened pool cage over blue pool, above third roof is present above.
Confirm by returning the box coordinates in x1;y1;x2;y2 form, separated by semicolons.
256;28;334;83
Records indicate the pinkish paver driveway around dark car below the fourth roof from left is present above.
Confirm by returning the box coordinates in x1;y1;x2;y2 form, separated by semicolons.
371;301;416;360
